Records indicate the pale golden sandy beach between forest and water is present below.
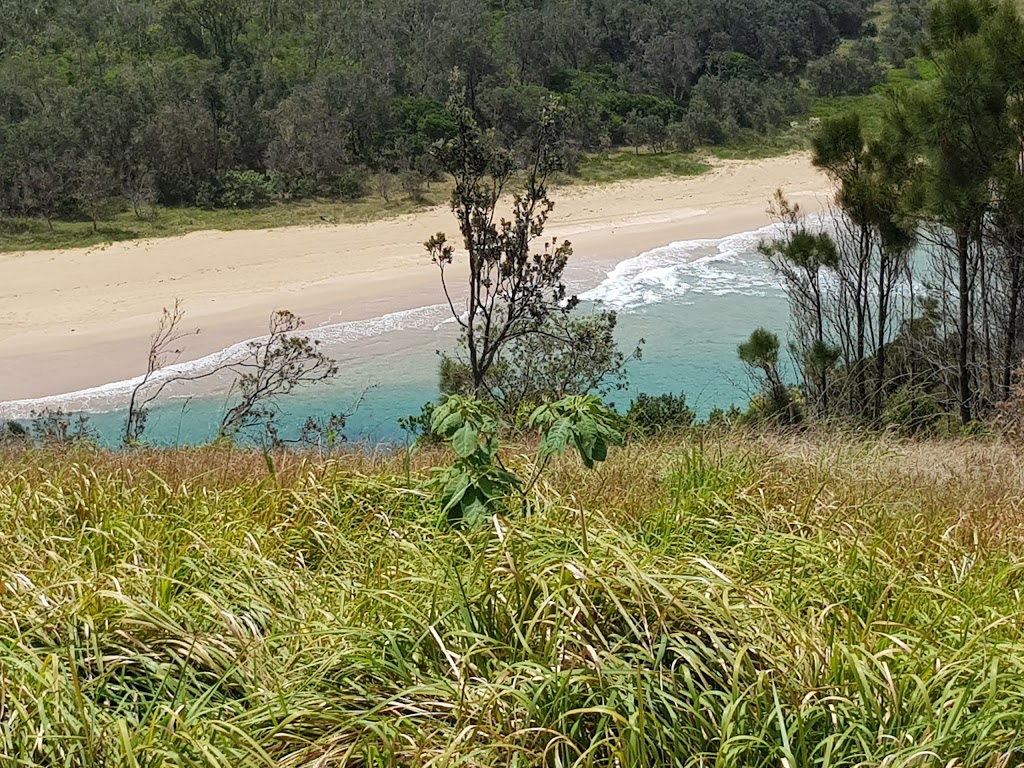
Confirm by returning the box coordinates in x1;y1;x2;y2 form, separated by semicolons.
0;154;829;401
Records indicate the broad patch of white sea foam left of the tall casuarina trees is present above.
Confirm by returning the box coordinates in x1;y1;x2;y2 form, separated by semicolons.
581;225;779;310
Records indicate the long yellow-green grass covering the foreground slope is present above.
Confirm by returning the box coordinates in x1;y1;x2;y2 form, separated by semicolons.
0;436;1024;768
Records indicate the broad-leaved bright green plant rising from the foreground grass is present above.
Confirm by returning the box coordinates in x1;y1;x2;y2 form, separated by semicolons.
430;394;623;525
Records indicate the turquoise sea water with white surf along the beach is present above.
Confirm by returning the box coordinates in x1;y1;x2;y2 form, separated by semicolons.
0;228;787;444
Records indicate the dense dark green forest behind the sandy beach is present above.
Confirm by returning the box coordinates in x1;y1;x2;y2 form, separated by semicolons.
0;0;919;221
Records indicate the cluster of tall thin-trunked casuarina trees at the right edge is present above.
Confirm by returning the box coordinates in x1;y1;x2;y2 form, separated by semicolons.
739;0;1024;430
